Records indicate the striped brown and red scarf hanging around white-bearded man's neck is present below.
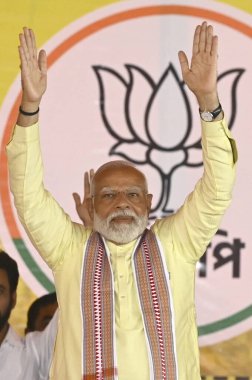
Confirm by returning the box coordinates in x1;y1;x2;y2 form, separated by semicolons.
81;229;178;380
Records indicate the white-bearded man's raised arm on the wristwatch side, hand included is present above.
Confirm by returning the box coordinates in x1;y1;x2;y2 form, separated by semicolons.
154;22;237;262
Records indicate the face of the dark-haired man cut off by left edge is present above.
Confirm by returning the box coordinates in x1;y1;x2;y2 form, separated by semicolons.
0;269;16;331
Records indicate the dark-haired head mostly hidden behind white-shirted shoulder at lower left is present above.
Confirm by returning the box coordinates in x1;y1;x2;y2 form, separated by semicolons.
25;292;58;334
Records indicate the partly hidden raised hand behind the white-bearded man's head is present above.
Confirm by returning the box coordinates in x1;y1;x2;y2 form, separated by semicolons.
73;169;94;227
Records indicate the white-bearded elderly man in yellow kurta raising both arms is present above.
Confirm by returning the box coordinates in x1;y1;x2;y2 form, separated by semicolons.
7;22;237;380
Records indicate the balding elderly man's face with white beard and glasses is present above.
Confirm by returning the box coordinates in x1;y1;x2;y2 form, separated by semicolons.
93;166;152;243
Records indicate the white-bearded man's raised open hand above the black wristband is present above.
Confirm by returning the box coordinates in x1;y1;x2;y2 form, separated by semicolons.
18;27;47;112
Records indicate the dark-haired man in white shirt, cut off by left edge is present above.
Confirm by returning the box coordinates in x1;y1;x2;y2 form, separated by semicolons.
0;251;58;380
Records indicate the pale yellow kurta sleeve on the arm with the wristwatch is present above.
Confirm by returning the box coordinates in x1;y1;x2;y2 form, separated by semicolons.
153;119;237;262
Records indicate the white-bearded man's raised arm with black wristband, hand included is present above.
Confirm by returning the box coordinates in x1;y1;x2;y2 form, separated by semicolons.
7;28;83;269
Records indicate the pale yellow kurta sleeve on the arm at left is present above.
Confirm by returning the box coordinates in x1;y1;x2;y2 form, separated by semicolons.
7;124;84;269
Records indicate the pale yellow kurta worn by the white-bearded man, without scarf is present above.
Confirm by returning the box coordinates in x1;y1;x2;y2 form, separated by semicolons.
7;120;237;380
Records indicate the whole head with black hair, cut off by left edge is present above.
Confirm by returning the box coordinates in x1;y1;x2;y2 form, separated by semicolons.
0;251;19;343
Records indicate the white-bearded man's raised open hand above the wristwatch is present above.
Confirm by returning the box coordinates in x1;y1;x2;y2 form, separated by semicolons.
179;21;219;110
